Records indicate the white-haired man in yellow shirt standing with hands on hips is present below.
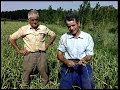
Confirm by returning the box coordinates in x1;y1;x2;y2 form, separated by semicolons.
9;10;56;87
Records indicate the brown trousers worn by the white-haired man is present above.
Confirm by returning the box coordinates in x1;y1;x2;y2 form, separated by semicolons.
22;52;49;84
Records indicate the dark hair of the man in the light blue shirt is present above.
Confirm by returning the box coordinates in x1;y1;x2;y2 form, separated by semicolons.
64;13;79;23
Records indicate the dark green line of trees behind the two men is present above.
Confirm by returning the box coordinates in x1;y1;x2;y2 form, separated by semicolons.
1;1;118;26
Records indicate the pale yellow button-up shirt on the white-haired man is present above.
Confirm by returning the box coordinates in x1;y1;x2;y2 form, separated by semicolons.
10;24;55;52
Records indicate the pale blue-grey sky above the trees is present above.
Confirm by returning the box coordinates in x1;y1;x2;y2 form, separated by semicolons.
1;1;118;11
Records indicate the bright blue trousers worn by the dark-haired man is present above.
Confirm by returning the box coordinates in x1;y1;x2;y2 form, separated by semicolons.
59;64;94;89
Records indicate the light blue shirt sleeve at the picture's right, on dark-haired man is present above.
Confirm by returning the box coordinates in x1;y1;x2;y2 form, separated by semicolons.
86;35;94;55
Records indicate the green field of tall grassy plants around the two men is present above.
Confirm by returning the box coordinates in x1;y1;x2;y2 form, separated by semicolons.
1;21;118;89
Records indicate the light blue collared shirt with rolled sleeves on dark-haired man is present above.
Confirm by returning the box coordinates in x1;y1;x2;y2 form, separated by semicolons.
57;31;94;59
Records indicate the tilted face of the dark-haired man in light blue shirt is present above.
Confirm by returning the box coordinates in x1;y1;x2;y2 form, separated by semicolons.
66;20;80;35
